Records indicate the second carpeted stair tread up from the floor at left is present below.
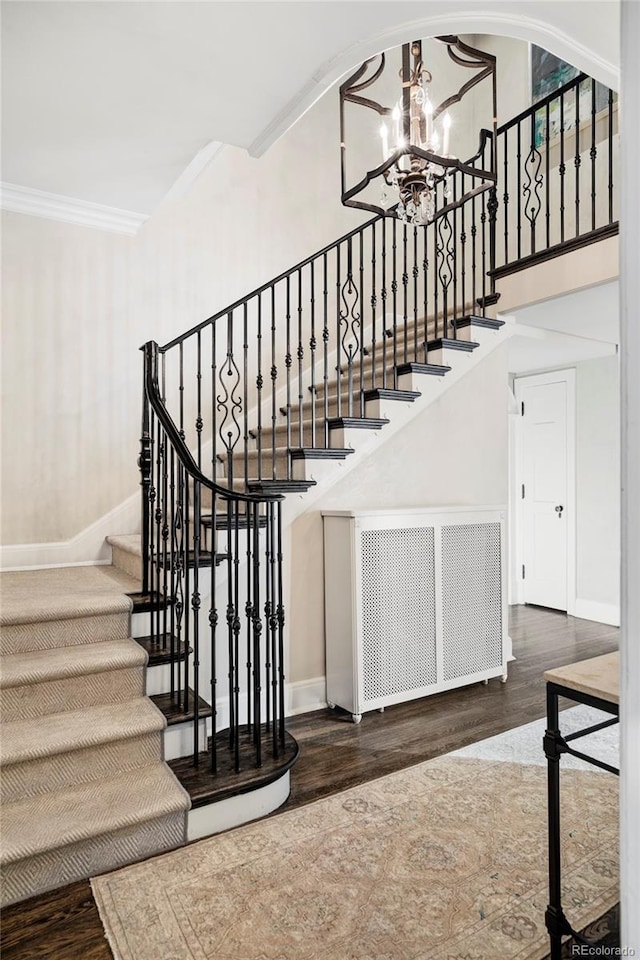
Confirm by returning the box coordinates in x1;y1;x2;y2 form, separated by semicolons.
0;697;166;767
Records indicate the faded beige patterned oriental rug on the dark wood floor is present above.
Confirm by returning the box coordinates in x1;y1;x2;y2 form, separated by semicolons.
92;707;618;960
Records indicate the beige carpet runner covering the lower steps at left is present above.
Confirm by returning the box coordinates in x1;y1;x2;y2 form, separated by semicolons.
0;567;189;905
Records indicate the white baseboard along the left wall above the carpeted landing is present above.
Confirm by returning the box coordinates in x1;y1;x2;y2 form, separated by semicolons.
0;493;140;570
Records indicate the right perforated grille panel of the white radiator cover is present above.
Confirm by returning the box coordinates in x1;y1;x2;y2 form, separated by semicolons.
442;523;502;680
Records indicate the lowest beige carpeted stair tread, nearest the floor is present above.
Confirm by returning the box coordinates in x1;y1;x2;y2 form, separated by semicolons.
0;763;190;865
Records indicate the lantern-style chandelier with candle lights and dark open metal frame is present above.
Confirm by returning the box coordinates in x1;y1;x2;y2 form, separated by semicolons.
340;36;497;226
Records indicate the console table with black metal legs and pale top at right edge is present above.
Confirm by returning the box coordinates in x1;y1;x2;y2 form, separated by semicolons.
544;653;620;960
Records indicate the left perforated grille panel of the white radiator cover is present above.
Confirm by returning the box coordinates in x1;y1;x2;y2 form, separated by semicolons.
362;527;436;701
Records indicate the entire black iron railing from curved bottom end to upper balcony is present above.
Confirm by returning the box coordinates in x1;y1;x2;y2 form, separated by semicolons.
140;67;617;788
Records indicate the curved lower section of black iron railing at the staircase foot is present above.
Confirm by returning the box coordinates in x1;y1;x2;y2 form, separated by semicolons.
140;342;285;774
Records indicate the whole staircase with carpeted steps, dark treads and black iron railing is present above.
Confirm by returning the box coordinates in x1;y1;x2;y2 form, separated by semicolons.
0;67;617;903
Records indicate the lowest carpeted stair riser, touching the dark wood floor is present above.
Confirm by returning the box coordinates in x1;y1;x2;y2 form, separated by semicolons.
2;812;186;907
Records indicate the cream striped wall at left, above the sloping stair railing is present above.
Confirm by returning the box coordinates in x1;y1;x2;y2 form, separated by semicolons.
1;82;362;559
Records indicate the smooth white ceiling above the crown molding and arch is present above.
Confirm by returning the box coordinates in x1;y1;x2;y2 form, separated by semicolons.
2;0;619;213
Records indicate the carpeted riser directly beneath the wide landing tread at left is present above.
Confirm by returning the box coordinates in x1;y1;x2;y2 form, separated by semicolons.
0;613;129;656
